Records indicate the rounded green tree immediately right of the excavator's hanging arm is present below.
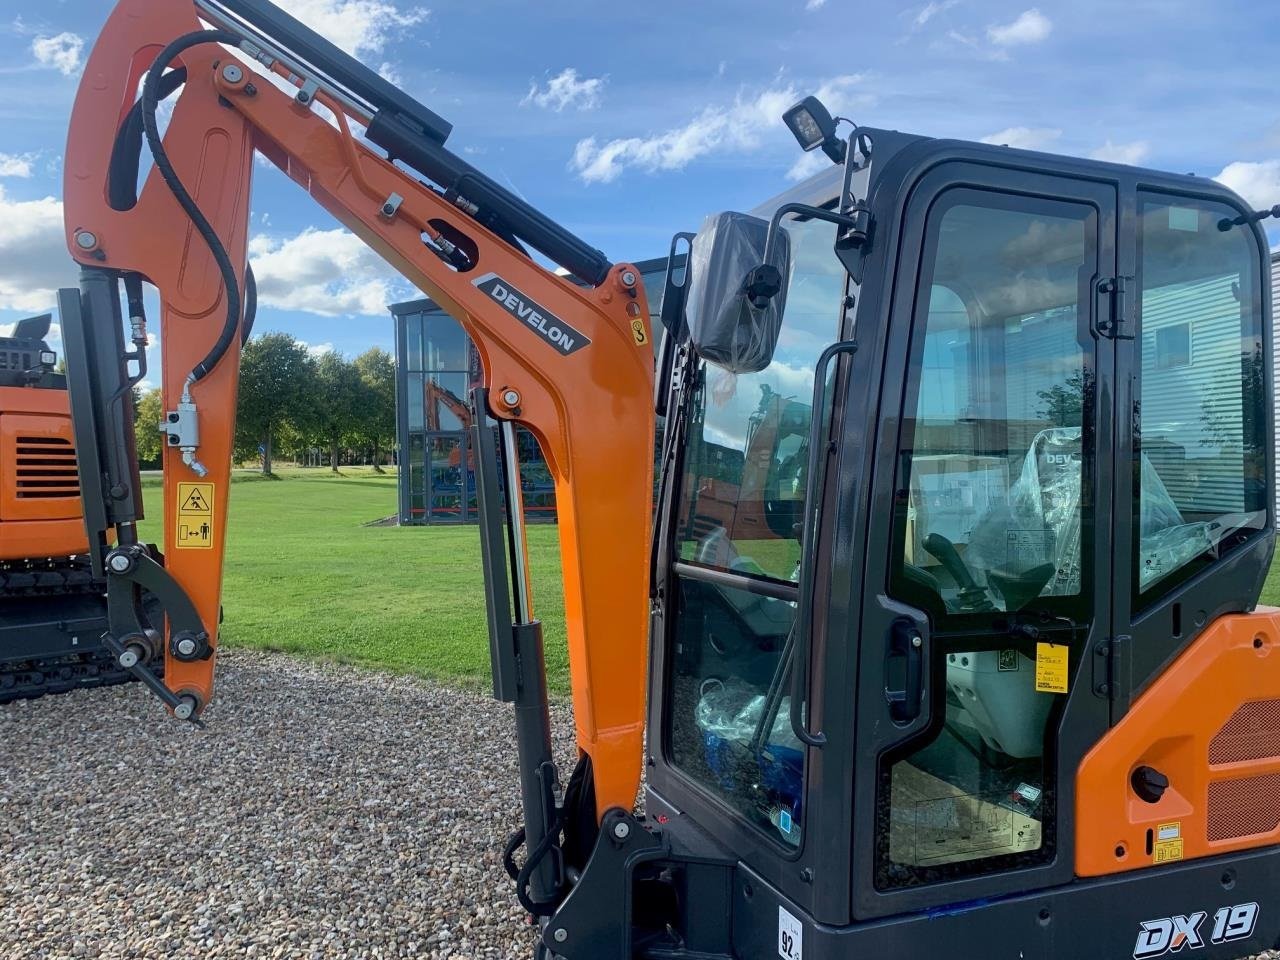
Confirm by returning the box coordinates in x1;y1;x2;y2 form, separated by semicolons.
236;333;316;475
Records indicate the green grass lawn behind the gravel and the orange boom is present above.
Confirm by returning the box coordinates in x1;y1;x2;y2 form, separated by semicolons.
132;467;568;694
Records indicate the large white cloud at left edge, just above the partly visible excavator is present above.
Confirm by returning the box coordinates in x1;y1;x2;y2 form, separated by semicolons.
0;184;76;314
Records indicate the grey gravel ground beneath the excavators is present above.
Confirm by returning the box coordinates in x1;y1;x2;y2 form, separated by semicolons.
0;650;1280;960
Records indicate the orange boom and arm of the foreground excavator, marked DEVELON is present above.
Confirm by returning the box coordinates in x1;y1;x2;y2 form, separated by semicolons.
64;0;654;813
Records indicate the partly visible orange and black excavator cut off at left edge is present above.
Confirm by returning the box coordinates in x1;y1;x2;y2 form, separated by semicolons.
0;314;164;703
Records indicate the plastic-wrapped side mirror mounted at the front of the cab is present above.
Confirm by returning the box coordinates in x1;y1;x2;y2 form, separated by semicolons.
687;212;791;374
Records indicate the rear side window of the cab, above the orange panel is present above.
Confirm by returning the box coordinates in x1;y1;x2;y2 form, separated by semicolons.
1133;193;1270;605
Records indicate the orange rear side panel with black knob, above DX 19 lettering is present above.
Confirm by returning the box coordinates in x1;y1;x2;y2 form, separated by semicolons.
1075;608;1280;877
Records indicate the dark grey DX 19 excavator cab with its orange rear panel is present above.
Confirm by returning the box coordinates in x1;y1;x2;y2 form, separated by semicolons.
646;128;1280;960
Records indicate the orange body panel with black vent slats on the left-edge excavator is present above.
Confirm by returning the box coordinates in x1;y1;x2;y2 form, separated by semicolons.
0;387;88;561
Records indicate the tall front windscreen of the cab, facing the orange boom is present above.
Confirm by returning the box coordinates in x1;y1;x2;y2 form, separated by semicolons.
668;212;845;847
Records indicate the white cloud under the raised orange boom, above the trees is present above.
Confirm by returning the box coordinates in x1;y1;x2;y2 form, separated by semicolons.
248;227;412;316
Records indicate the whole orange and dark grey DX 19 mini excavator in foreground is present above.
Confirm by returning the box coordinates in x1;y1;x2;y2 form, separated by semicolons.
59;0;1280;960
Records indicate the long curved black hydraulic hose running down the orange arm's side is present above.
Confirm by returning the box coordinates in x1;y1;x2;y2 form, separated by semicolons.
142;29;241;383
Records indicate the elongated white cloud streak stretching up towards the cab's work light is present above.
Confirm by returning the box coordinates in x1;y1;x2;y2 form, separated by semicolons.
570;74;869;183
